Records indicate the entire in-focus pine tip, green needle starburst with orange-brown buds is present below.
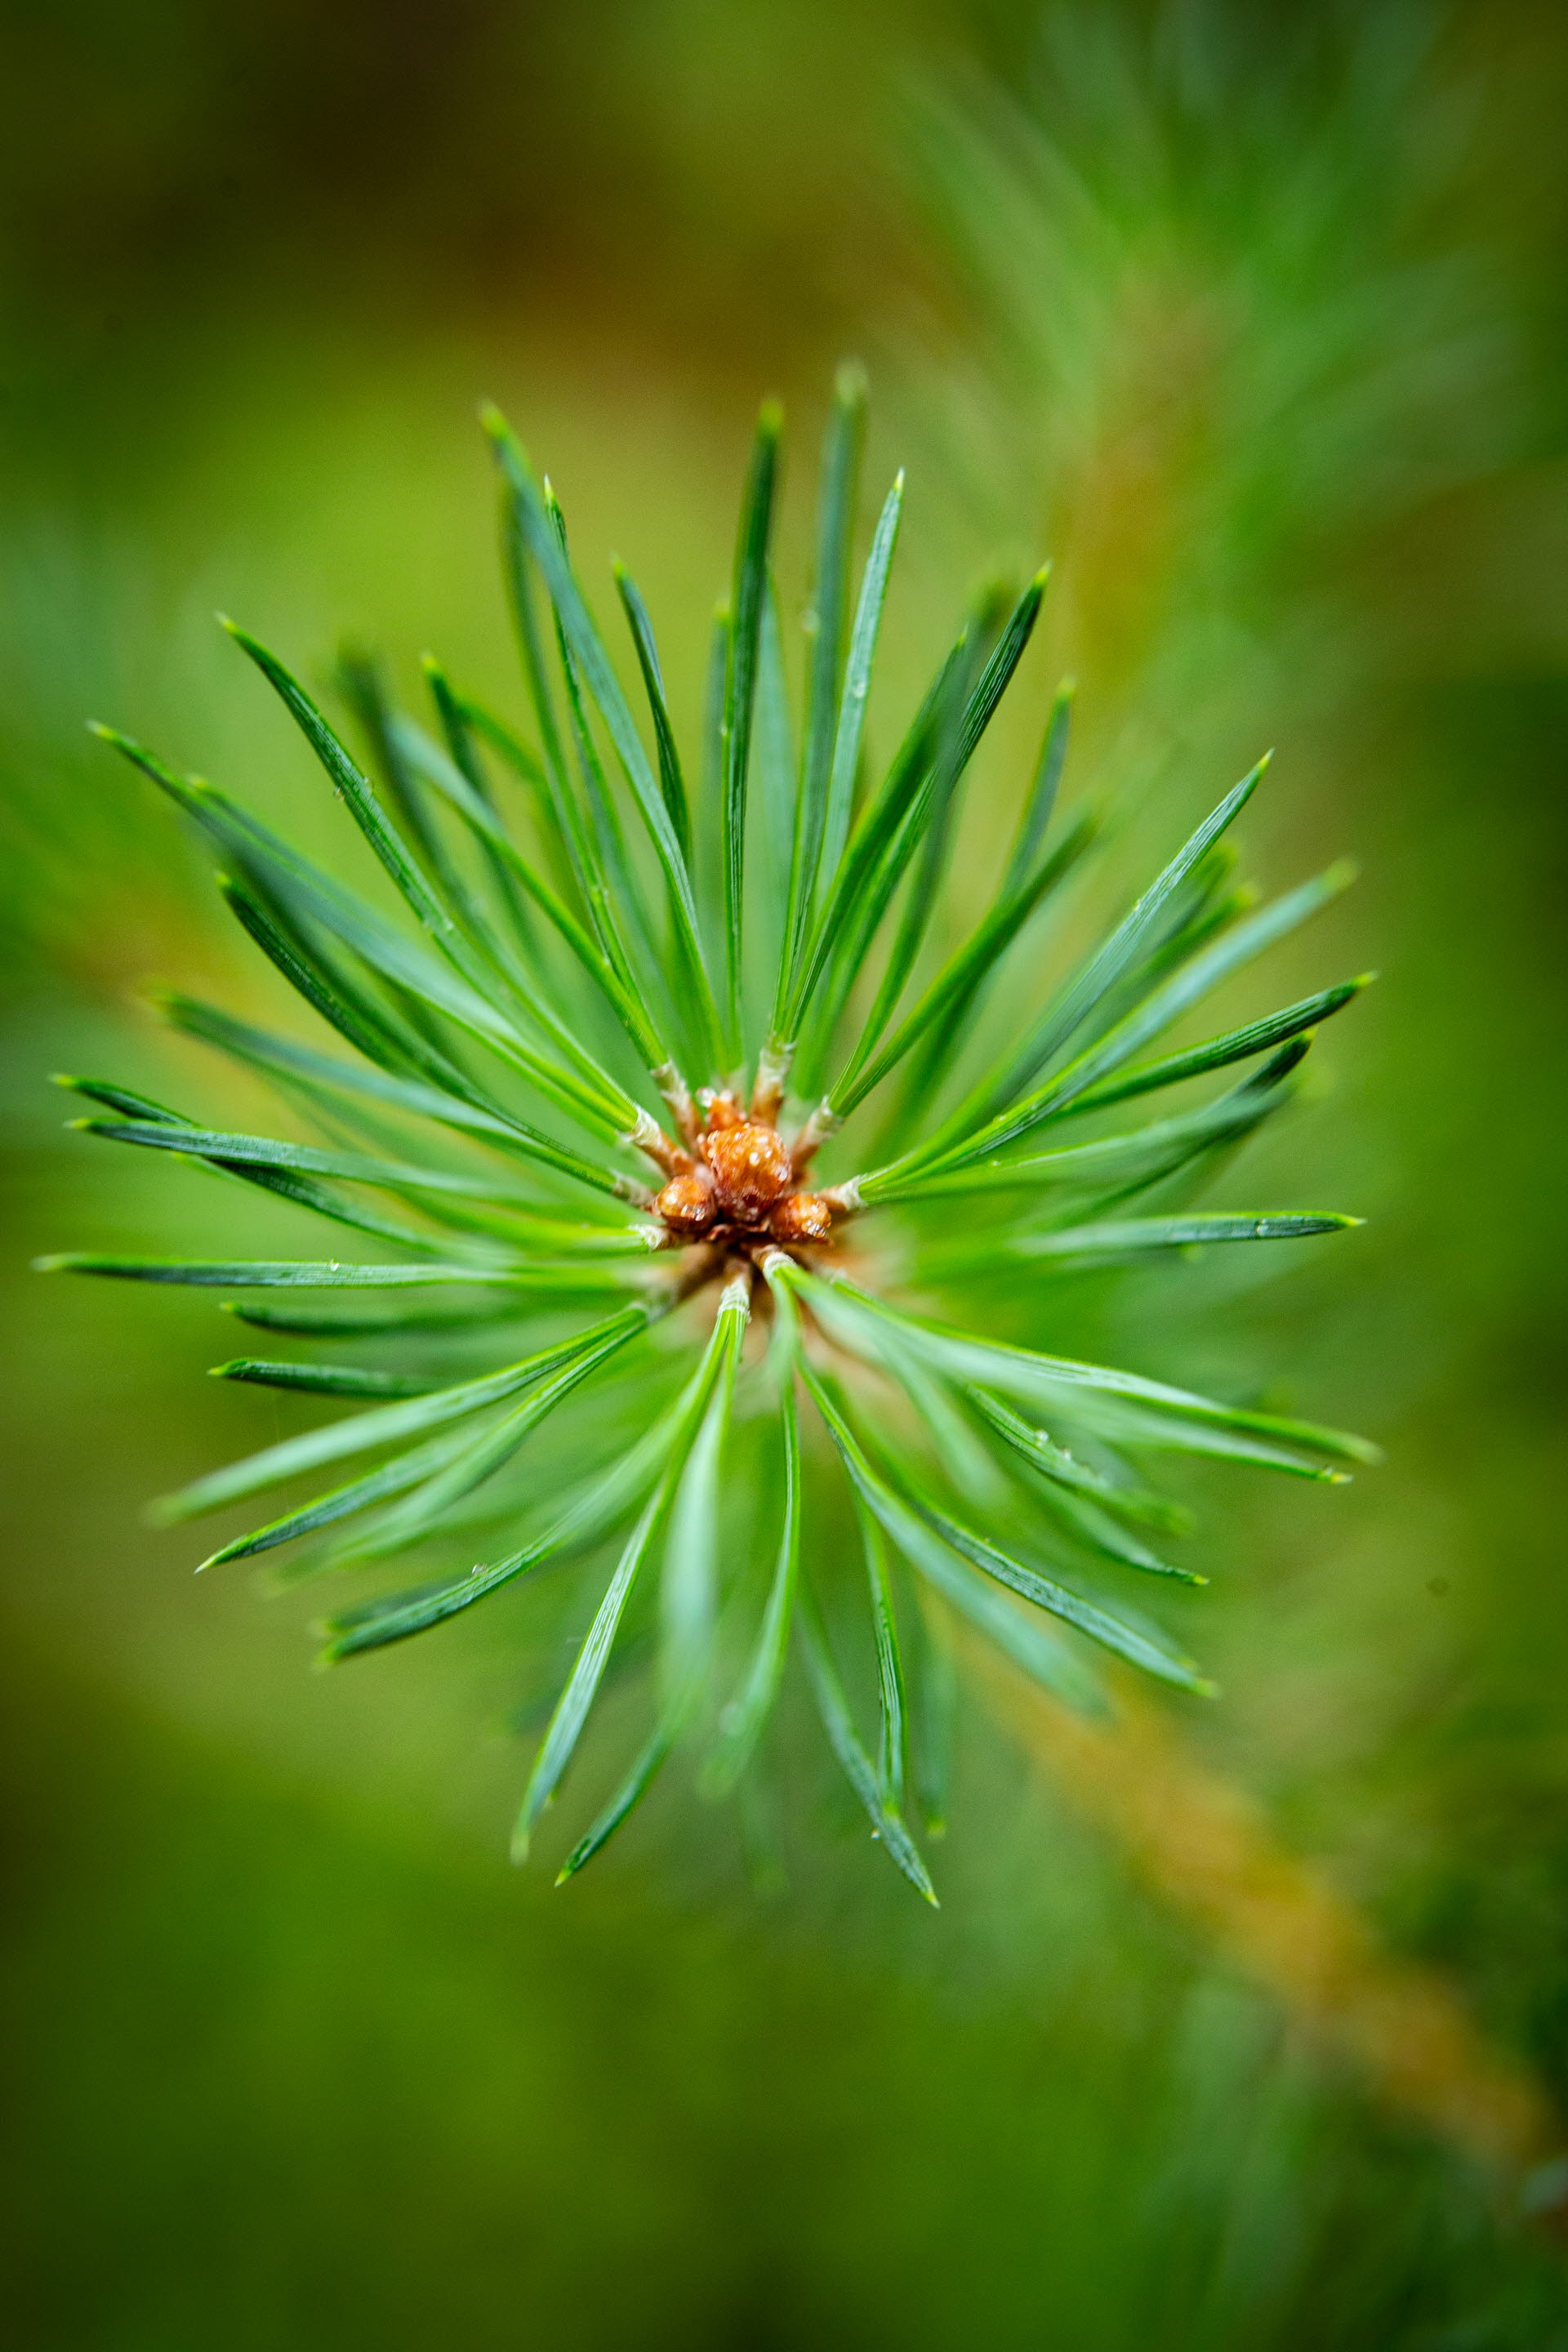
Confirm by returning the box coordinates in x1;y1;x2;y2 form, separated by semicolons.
45;372;1370;1900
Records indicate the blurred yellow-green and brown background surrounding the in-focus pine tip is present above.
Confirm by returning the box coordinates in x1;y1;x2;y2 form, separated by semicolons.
0;0;1568;2352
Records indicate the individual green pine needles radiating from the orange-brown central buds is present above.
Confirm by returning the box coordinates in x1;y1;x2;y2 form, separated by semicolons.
49;358;1380;1910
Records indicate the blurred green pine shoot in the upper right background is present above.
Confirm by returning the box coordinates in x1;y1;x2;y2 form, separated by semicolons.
920;0;1568;741
